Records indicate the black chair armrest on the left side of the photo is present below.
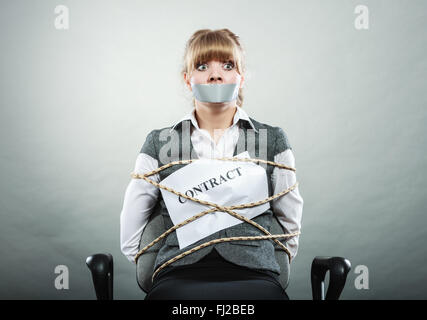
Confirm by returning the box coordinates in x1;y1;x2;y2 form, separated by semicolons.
86;253;113;300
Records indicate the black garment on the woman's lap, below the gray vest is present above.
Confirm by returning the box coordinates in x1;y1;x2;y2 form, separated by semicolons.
145;249;289;300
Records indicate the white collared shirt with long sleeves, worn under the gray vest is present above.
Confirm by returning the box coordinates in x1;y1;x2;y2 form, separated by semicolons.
120;106;304;263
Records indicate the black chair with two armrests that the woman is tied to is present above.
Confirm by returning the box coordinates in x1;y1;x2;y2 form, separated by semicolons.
86;214;351;300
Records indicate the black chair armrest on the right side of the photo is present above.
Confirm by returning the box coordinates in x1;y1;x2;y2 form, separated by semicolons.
311;257;351;300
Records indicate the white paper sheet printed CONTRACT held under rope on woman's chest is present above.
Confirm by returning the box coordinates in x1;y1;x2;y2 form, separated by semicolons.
160;151;270;249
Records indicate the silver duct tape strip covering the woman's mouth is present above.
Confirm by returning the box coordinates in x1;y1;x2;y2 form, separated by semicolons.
191;83;240;103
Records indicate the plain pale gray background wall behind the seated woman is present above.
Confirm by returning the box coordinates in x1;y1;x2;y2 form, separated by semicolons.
0;0;427;299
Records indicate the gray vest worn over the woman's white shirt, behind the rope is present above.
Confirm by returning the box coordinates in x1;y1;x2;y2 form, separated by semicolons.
141;118;292;274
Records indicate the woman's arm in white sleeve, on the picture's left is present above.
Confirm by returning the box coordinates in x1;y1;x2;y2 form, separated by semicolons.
120;152;160;263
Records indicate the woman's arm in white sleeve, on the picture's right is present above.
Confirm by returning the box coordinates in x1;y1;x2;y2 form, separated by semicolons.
271;149;304;259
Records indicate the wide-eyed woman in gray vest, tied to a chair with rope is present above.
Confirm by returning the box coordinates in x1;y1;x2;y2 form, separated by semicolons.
121;29;303;300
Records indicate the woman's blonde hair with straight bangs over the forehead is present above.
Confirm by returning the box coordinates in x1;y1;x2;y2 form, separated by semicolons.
181;29;246;107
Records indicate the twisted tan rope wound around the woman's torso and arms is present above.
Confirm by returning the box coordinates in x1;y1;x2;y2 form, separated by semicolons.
131;158;301;280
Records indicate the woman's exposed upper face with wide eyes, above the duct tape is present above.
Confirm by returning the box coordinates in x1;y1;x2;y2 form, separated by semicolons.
184;60;244;90
